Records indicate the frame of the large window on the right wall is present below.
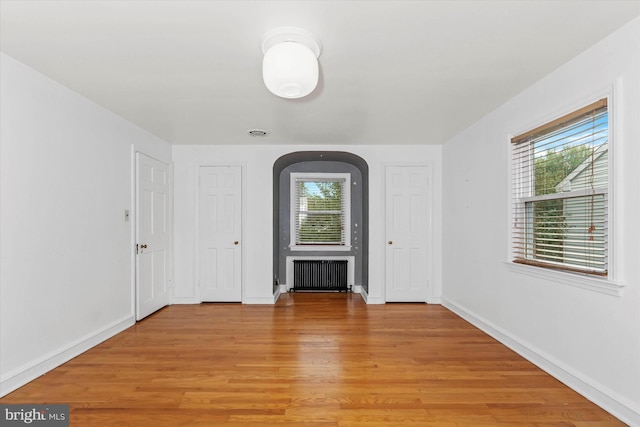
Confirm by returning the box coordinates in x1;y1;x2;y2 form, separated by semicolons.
508;95;608;278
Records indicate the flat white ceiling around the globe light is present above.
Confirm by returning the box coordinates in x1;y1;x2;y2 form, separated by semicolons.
0;0;640;144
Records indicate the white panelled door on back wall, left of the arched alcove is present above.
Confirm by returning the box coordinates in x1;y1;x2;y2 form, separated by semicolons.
198;166;242;302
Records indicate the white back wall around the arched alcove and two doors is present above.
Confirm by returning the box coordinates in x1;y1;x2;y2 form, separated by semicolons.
173;145;442;304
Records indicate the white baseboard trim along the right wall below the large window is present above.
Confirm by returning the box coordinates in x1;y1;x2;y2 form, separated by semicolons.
442;298;640;426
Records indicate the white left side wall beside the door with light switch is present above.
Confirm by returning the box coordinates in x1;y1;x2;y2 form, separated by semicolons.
0;54;171;395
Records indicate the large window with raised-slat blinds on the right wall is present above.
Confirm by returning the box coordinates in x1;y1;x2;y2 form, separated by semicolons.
511;99;609;276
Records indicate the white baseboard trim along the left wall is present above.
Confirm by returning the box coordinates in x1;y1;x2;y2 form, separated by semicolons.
0;315;136;397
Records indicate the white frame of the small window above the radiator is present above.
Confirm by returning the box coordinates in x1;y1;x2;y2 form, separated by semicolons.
289;172;351;252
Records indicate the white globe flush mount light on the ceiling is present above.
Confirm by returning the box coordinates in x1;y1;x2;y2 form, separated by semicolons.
262;27;321;99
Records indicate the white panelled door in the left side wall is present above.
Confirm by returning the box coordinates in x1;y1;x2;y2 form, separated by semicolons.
136;153;171;320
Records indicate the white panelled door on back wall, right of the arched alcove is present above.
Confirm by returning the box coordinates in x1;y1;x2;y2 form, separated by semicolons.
385;166;430;302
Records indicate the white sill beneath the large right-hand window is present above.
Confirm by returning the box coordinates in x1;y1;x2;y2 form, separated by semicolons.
505;262;624;297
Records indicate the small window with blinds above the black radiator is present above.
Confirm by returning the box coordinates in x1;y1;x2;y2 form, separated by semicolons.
291;173;350;249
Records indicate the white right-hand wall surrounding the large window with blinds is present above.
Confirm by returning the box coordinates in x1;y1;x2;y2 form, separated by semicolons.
443;19;640;425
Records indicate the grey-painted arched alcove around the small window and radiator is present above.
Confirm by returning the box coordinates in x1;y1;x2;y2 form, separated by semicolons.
273;151;369;293
